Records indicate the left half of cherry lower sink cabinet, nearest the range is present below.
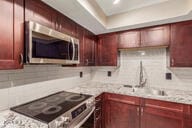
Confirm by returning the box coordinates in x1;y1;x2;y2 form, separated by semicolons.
103;93;140;128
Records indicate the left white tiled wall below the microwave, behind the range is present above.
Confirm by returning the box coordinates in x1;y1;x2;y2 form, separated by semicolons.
0;65;91;111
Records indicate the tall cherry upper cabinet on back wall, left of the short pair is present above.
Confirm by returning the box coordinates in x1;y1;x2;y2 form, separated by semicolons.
97;33;118;66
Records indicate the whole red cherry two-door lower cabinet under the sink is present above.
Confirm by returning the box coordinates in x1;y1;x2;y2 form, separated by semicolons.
102;93;192;128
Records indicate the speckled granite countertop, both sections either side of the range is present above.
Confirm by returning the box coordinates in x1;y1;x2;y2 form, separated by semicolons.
0;82;192;128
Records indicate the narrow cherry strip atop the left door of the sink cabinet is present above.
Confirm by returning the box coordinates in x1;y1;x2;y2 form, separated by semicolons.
105;93;140;105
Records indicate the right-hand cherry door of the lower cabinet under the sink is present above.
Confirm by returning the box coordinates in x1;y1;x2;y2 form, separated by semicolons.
141;100;185;128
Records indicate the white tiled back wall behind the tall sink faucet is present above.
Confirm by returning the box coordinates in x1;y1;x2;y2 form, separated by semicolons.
92;48;192;91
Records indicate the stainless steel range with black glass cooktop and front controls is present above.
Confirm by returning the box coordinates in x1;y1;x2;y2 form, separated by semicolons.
11;91;95;128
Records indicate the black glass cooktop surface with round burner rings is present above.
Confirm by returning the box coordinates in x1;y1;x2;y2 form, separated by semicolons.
11;91;92;123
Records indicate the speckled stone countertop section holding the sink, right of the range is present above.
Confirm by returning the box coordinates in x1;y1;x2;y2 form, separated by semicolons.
67;83;192;105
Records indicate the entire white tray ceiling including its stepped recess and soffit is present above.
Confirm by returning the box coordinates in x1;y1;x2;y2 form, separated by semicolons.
42;0;192;34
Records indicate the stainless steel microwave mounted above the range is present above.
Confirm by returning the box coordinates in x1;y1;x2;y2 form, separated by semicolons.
25;21;79;65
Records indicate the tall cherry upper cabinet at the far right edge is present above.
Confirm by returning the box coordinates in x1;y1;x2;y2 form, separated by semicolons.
170;21;192;67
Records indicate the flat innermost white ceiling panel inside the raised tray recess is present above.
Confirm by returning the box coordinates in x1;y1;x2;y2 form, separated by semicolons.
96;0;170;16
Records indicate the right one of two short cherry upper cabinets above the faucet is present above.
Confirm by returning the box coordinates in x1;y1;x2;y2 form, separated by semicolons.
141;25;170;47
